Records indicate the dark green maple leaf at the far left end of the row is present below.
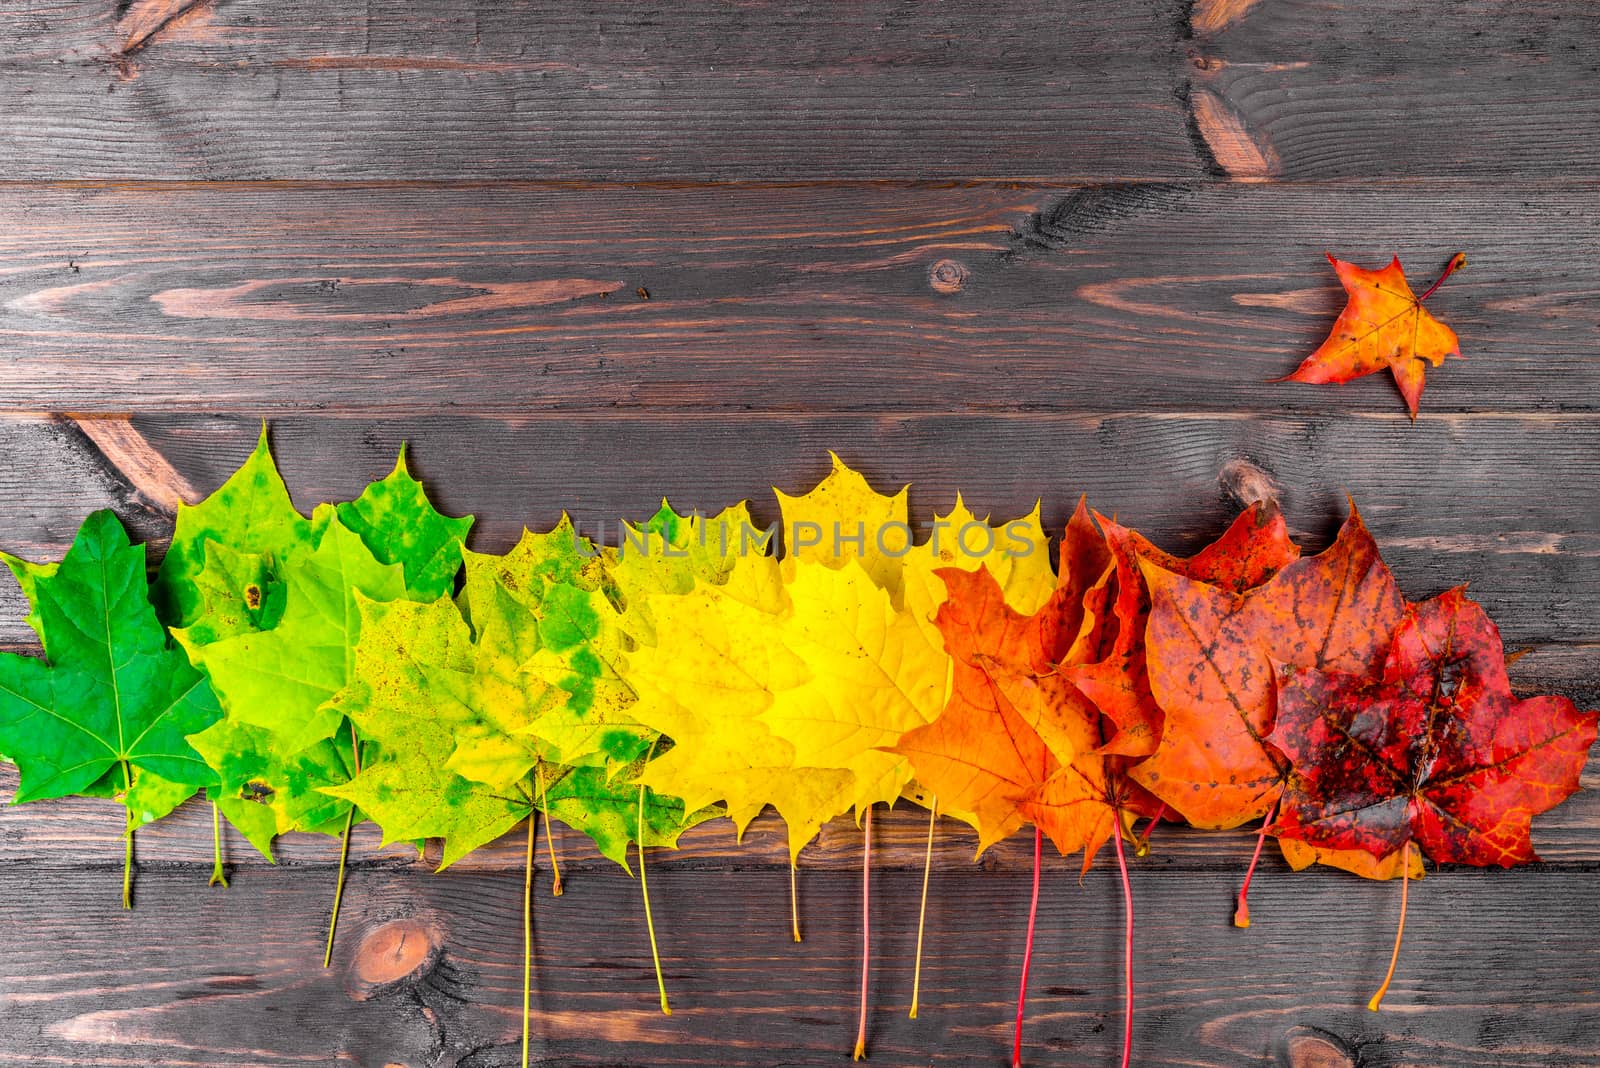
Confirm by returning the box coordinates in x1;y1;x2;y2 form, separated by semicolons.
0;512;219;801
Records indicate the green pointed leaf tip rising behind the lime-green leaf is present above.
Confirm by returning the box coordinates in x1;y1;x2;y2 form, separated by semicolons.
338;446;472;601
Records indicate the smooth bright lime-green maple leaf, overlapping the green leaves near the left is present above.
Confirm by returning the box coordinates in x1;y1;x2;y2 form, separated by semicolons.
173;505;405;755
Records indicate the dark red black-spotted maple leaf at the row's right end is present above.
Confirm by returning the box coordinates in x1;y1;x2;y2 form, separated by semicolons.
1267;590;1597;867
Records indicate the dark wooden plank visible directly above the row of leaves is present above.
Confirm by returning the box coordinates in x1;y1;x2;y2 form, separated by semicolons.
0;411;1600;648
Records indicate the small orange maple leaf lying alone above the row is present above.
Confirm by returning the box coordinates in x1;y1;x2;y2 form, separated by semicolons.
1274;253;1467;419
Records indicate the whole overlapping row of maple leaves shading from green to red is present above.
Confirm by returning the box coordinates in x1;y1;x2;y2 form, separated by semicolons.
0;432;1597;1058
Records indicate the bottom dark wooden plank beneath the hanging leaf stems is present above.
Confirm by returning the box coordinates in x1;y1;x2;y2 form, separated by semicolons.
0;862;1600;1068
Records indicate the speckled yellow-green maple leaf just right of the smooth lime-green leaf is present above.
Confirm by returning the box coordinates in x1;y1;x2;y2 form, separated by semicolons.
323;598;533;868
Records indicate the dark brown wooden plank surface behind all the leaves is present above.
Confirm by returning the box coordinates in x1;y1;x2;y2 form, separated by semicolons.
0;0;1600;1068
